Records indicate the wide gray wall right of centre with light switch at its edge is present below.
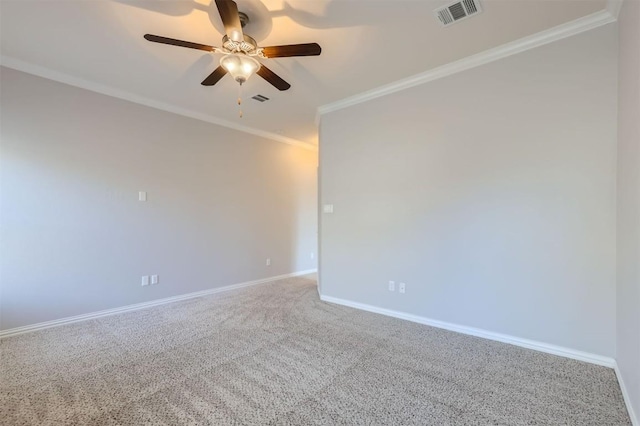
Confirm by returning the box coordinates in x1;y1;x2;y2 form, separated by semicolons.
320;25;617;357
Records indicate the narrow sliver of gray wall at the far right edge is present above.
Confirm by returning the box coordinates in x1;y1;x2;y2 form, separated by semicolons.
616;0;640;420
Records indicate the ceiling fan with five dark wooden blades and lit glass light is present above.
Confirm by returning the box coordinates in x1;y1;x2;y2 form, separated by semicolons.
144;0;322;90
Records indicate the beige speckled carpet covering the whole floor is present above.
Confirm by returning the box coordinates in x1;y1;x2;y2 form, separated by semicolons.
0;278;630;426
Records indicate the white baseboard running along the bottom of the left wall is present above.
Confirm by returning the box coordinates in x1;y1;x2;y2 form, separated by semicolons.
0;269;317;339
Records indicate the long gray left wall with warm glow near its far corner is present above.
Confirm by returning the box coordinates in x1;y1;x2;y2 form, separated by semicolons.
0;68;317;329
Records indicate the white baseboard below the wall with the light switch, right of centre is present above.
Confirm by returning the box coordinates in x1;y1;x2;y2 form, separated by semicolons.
320;295;615;368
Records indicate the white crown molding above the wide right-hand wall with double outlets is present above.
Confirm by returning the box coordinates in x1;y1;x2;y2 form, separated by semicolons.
316;9;620;116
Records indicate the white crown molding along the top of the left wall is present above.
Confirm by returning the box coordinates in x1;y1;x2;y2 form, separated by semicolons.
0;55;318;151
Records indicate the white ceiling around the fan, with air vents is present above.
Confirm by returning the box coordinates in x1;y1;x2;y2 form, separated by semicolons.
0;0;606;144
